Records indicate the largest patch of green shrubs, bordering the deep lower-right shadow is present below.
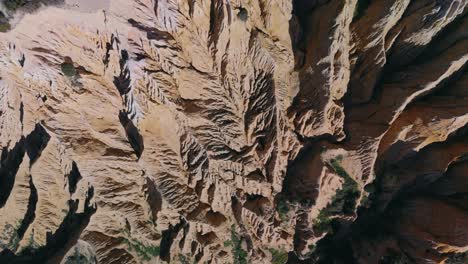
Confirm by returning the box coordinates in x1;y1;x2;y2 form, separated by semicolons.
314;155;360;233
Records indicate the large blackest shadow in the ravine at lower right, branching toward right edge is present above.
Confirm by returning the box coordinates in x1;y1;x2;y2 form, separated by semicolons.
309;126;468;264
